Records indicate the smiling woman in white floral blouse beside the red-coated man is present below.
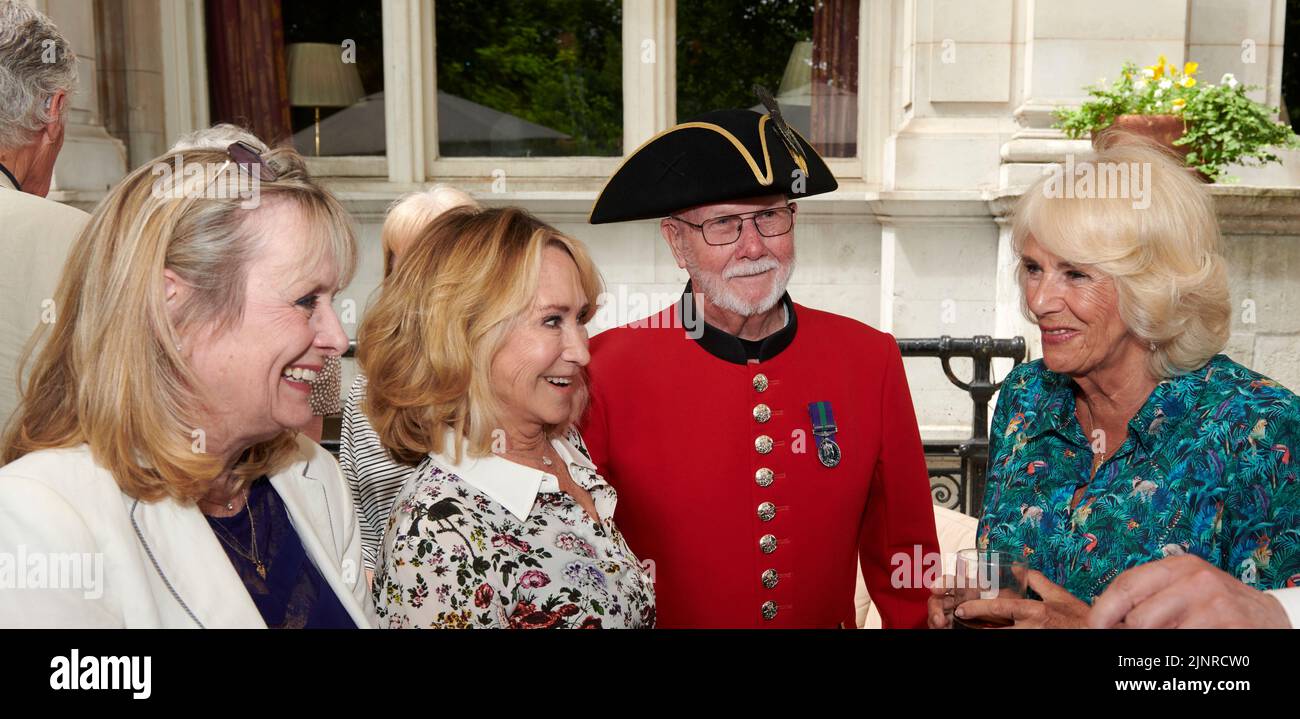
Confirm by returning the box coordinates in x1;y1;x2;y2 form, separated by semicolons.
358;208;655;628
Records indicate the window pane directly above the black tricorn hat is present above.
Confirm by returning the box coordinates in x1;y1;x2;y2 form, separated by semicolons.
677;0;859;157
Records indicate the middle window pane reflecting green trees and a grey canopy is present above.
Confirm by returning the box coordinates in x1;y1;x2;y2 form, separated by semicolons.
434;0;623;157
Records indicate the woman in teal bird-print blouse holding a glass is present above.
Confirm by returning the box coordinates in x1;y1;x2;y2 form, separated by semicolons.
931;140;1300;627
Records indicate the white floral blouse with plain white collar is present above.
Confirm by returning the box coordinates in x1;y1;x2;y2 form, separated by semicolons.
373;434;655;629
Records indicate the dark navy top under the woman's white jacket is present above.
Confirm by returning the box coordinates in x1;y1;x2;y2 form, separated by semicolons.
208;477;356;621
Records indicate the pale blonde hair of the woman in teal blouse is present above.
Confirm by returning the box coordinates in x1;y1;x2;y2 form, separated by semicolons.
1011;135;1231;378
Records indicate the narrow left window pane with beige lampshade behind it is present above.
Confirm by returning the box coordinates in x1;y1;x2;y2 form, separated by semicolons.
282;0;386;156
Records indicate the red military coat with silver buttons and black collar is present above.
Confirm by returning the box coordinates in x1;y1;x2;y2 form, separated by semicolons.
581;286;937;628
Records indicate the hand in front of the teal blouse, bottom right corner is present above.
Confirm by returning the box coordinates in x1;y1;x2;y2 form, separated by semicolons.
1088;555;1291;629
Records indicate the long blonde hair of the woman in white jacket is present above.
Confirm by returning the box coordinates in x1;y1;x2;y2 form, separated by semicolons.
0;143;356;503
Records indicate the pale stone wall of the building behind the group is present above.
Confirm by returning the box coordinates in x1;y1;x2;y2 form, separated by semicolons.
33;0;1300;438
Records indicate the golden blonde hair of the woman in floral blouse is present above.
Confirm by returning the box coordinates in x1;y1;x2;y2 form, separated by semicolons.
358;207;602;463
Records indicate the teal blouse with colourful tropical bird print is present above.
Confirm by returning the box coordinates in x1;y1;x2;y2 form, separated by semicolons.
979;355;1300;601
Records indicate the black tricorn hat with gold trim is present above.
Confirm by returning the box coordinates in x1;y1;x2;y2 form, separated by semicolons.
588;109;840;225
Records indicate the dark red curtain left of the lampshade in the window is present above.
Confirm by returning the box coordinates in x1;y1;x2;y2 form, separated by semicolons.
205;0;293;146
